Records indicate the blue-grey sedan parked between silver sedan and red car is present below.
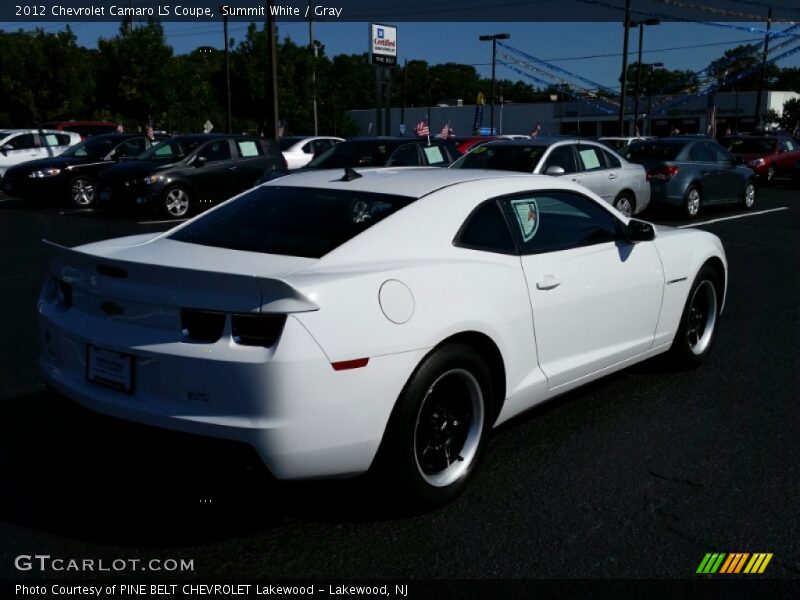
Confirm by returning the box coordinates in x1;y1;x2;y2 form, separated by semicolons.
622;136;756;219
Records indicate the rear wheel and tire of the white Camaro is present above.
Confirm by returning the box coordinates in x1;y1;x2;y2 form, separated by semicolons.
377;344;494;507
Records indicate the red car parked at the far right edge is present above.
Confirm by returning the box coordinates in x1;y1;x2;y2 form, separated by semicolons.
720;135;800;183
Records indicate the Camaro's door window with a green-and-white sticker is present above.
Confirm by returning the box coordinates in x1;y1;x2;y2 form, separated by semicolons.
502;192;619;254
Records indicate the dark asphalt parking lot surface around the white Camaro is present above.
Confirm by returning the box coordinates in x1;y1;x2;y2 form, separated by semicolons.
0;184;800;579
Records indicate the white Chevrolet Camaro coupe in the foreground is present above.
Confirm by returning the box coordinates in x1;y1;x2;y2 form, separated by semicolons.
38;169;727;505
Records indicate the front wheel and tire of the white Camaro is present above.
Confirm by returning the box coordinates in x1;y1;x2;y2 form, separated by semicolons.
669;265;722;368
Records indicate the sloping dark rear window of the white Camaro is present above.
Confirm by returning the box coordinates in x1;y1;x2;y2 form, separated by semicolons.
169;185;415;258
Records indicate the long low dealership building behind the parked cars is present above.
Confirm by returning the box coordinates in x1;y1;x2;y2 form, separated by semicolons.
349;91;800;137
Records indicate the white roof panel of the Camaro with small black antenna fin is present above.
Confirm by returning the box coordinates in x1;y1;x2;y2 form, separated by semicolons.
265;167;552;198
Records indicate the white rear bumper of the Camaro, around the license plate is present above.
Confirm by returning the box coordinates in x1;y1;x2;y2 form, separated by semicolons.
39;302;425;479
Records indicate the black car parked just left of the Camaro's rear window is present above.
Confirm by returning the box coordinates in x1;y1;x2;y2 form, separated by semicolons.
97;134;284;218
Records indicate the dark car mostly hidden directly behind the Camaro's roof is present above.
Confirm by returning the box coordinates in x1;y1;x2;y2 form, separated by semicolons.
307;137;454;169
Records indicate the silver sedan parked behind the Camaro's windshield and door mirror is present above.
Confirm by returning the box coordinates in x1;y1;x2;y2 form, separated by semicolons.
451;138;650;216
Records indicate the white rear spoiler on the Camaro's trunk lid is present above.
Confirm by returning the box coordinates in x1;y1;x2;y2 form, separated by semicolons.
42;239;319;314
